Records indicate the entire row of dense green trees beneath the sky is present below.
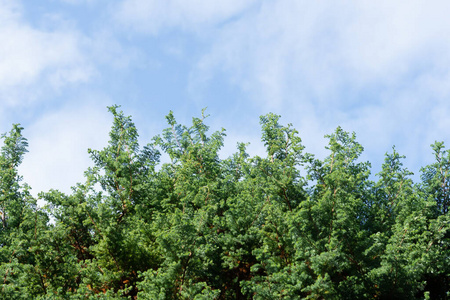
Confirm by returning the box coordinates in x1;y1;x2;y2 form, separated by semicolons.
0;106;450;299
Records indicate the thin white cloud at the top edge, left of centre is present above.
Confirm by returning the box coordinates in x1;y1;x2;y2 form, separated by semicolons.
114;0;255;34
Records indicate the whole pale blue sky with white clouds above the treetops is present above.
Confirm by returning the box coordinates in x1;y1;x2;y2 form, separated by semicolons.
0;0;450;195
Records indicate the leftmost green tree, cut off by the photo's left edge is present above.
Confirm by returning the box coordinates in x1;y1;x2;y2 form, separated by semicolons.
0;124;47;299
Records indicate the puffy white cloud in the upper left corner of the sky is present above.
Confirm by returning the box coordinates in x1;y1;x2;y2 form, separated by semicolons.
0;1;94;105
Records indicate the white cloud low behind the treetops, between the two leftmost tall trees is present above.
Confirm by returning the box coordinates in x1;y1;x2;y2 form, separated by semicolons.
19;101;112;195
